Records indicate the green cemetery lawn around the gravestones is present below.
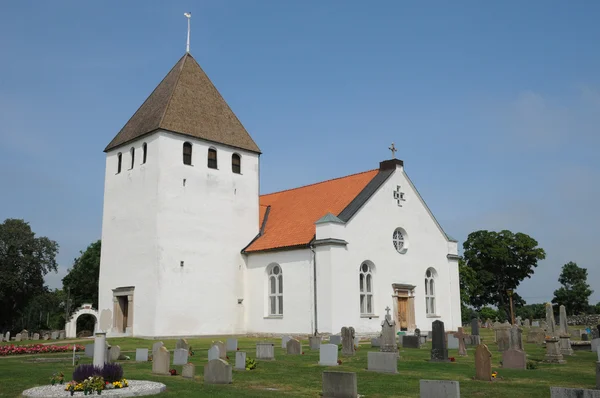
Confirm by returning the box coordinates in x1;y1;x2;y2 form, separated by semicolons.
0;329;596;398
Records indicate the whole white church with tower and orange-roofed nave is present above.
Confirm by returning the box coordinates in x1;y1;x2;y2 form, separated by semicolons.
98;53;461;337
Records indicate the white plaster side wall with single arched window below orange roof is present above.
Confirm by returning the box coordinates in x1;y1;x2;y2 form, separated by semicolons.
244;249;314;334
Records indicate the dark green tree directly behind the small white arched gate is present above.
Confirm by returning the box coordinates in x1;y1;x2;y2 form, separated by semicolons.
63;240;102;312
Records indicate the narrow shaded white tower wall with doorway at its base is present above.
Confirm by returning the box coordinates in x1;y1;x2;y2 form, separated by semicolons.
98;134;159;335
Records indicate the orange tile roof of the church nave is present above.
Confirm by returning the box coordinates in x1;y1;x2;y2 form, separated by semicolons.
245;170;378;252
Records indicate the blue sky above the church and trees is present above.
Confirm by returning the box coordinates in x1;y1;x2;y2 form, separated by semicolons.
0;0;600;303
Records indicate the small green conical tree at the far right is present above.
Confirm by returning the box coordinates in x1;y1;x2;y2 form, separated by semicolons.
552;261;594;315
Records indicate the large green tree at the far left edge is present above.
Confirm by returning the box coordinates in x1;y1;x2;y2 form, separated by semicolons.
0;219;58;329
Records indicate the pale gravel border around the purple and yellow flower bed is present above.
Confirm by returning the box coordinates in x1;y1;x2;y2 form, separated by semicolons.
23;380;167;398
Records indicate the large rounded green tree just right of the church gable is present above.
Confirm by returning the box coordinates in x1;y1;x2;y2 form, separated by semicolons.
463;230;546;319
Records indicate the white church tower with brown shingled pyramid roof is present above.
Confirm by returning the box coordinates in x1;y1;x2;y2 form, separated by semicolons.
98;53;260;336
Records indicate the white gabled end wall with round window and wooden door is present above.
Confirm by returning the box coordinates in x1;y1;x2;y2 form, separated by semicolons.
317;163;460;333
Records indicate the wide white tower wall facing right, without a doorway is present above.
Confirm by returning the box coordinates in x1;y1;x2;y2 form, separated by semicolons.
154;132;259;336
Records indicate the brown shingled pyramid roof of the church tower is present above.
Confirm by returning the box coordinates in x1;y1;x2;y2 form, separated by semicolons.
104;53;260;153
